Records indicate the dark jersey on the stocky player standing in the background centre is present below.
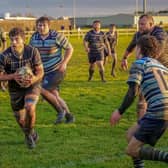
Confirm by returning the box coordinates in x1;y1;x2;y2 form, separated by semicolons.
84;30;107;53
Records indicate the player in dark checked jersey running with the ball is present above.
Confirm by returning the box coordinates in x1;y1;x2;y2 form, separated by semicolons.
0;28;43;148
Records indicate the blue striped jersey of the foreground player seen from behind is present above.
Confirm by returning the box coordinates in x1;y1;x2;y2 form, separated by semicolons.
127;57;168;120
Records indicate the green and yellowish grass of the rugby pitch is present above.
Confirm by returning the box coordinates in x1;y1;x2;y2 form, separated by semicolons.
0;36;168;168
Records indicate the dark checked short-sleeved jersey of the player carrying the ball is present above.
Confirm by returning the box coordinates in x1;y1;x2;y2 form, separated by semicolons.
0;45;42;90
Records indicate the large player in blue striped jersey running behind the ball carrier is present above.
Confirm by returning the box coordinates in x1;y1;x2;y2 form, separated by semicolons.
30;16;75;124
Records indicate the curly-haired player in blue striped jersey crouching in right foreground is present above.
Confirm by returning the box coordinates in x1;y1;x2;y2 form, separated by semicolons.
110;35;168;168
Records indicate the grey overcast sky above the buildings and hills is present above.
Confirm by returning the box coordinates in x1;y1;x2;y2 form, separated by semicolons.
0;0;168;17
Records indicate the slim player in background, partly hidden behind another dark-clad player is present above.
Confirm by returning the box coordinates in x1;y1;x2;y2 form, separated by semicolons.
104;24;118;77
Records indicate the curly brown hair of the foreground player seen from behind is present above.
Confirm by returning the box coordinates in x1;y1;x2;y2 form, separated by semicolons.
137;35;160;58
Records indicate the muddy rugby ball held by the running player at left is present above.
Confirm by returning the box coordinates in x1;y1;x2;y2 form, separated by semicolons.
16;66;33;88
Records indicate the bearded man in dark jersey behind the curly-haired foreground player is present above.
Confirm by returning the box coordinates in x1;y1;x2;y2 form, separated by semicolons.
121;14;168;118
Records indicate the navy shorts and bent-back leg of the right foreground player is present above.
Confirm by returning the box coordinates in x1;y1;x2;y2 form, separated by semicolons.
127;117;168;163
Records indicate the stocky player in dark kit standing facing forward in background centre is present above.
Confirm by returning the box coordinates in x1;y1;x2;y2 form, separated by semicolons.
83;20;111;82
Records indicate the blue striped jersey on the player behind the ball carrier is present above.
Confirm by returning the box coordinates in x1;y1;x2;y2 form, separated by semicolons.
30;30;72;74
